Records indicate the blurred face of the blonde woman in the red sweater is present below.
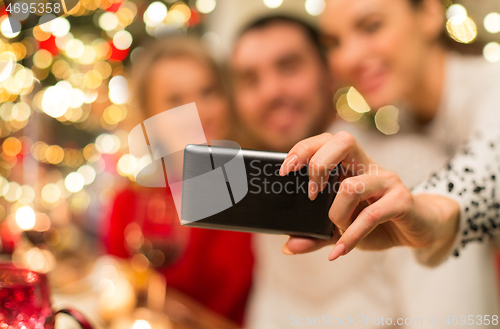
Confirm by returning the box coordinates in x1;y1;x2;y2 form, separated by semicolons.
146;57;230;140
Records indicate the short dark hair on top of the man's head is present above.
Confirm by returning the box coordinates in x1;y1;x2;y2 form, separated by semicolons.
238;15;326;63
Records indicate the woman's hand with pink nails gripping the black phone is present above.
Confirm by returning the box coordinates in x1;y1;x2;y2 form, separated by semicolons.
280;132;459;260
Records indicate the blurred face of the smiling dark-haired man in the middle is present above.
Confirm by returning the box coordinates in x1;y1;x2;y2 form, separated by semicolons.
231;23;334;152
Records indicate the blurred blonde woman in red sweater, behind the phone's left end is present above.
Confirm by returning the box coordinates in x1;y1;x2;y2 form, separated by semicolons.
105;37;253;324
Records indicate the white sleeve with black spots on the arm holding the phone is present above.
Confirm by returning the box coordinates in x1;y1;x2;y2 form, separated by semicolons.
412;129;500;266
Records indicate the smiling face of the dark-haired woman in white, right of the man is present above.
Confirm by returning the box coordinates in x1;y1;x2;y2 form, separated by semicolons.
321;0;443;109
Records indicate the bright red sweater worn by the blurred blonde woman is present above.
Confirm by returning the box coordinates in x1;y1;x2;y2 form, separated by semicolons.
105;188;253;324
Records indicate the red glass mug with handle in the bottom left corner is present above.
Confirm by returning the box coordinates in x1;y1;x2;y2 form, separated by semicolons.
0;263;91;329
